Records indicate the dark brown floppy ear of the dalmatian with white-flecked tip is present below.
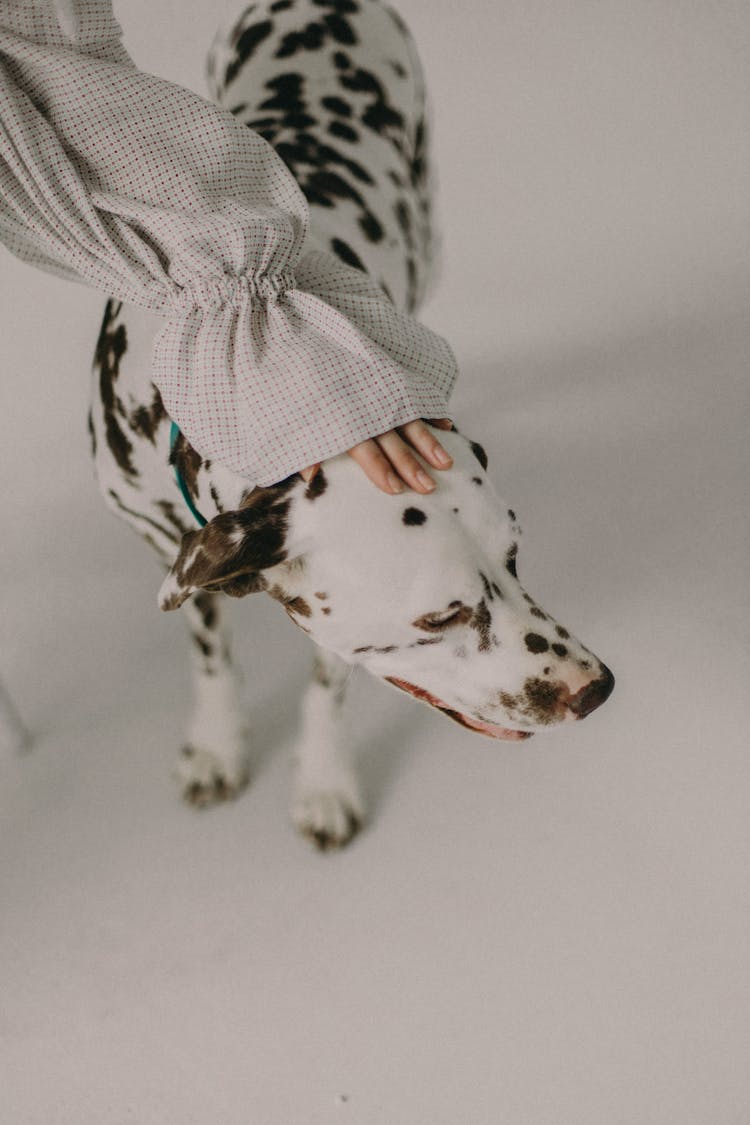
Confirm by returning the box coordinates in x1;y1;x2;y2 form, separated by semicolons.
159;482;299;610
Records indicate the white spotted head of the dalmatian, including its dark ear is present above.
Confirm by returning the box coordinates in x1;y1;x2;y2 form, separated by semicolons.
160;432;614;739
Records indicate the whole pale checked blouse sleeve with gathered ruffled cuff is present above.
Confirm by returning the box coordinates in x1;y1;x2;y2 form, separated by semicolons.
0;0;457;484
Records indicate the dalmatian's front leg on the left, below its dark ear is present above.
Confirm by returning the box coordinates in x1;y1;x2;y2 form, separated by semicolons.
177;591;247;808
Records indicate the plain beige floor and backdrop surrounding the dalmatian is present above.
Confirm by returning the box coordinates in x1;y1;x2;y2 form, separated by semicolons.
0;0;750;1125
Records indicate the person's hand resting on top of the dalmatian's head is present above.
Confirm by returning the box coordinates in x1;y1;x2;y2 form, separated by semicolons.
300;419;453;495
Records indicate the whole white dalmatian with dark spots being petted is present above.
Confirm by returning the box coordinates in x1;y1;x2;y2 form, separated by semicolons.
90;0;614;848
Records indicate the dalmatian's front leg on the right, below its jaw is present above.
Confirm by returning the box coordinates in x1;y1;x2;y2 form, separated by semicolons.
291;648;364;851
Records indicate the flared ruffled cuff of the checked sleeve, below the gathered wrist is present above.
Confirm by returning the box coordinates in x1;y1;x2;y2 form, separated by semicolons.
153;252;458;485
